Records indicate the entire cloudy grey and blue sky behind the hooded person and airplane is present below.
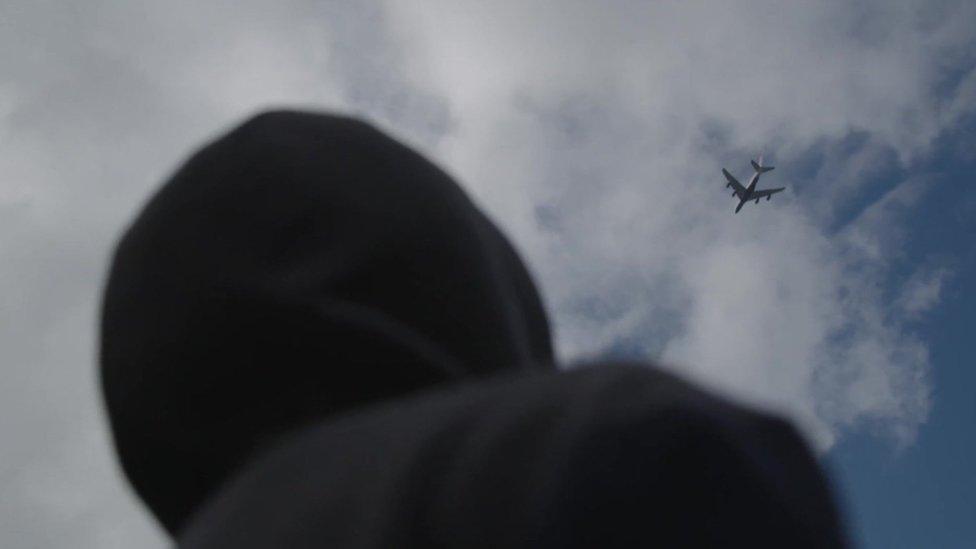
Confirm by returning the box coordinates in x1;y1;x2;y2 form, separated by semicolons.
0;0;976;548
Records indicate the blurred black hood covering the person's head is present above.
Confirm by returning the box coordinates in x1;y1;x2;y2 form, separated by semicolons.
101;112;552;532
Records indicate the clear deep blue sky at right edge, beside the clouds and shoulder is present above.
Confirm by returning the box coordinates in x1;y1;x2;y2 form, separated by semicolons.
826;121;976;549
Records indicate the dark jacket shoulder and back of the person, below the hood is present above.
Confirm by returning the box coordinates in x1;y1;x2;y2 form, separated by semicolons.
181;364;843;548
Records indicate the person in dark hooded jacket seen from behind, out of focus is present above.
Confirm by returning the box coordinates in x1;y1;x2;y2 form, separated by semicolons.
100;111;846;548
